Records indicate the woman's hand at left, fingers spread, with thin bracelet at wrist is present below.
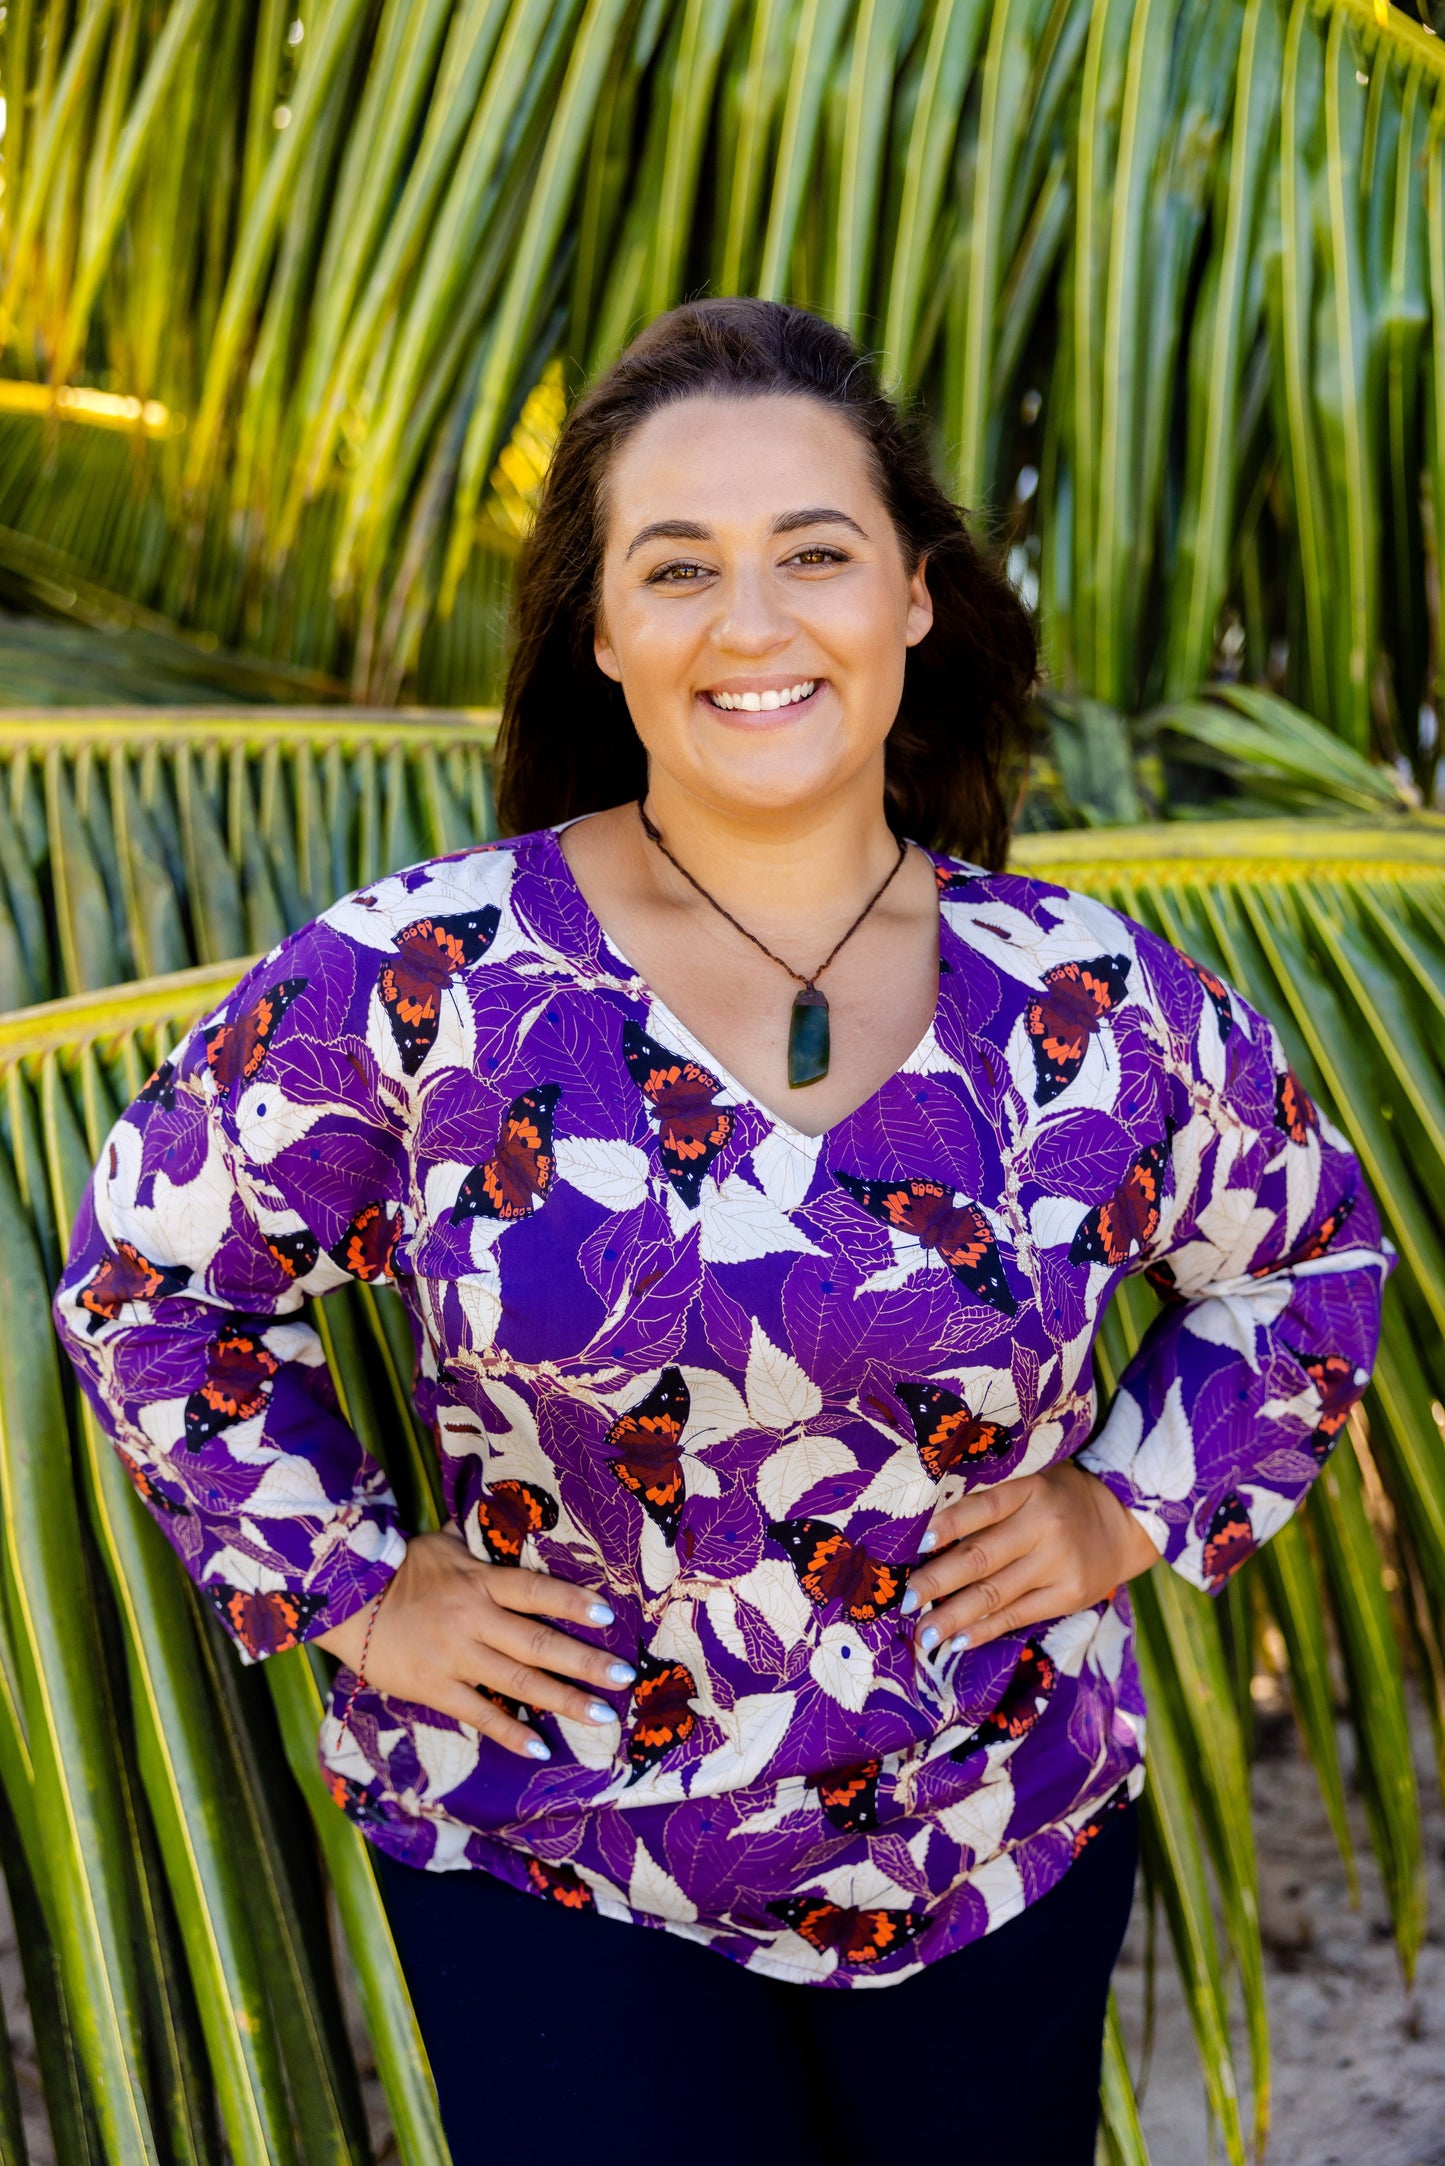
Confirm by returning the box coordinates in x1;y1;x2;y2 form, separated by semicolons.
316;1531;637;1759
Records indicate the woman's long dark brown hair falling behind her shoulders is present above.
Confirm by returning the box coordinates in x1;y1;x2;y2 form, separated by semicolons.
496;299;1038;866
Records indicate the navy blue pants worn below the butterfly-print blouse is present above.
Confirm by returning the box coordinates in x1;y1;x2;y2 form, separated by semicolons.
381;1806;1140;2166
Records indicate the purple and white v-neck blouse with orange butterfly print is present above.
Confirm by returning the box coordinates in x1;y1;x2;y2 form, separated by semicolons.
56;830;1391;1986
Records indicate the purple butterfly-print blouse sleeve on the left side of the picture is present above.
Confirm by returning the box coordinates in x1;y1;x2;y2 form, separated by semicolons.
54;923;405;1661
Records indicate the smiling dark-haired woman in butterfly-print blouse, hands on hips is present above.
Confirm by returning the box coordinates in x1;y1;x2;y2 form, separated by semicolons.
56;301;1389;2166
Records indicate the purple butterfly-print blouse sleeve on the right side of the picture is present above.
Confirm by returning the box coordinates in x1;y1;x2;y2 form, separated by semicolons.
1079;934;1393;1592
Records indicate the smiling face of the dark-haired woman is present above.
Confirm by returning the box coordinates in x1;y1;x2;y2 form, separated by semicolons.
596;396;934;812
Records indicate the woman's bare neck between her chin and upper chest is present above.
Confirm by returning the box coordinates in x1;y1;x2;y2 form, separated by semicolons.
637;758;899;921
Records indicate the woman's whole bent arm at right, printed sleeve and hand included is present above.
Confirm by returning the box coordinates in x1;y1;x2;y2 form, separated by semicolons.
910;934;1393;1653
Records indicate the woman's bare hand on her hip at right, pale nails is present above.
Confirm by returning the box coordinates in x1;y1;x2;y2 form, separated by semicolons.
903;1460;1159;1655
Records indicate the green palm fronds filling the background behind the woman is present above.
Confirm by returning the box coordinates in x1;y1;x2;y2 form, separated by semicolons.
0;0;1445;2166
